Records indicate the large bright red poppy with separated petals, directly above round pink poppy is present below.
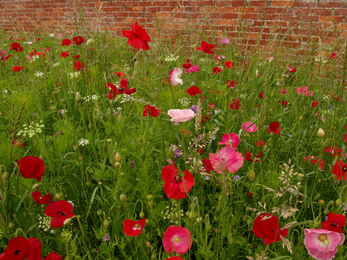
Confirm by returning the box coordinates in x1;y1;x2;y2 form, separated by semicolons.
161;165;194;200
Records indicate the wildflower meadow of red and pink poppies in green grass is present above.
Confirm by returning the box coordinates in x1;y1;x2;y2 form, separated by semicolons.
0;15;347;260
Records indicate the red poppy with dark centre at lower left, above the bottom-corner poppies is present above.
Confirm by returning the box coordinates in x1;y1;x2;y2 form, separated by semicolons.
45;200;75;228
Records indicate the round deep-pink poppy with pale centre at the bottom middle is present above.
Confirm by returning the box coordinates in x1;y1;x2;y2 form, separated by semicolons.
163;226;193;255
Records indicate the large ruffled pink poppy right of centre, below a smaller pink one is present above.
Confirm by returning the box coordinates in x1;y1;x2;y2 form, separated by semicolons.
209;147;244;174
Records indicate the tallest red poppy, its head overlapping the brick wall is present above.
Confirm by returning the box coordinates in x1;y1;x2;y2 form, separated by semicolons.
122;22;151;50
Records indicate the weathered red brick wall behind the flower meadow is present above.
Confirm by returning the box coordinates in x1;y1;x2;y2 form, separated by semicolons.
0;0;347;51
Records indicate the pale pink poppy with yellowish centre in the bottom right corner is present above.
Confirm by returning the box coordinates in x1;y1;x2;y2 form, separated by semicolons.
304;229;345;260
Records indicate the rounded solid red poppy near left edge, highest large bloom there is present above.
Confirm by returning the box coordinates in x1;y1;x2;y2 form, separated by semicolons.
17;156;45;181
